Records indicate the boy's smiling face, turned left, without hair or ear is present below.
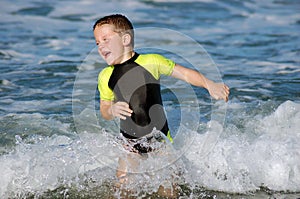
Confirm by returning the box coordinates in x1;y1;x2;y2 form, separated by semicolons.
94;24;126;65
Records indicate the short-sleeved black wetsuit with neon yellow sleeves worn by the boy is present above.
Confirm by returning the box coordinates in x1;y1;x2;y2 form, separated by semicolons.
98;53;175;141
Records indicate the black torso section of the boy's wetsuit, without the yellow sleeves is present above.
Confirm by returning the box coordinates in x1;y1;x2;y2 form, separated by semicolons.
108;54;169;138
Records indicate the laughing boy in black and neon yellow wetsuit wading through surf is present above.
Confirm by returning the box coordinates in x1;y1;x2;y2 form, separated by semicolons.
93;14;229;187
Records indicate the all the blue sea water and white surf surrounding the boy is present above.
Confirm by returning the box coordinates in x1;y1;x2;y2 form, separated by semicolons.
0;0;300;198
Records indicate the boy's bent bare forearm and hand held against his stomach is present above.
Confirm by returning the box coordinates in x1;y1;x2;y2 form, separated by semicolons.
100;100;132;120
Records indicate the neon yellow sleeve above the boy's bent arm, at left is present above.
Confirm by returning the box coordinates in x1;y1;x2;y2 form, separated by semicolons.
98;66;114;101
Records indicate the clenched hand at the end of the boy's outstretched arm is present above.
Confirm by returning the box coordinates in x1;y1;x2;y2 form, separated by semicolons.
208;82;230;102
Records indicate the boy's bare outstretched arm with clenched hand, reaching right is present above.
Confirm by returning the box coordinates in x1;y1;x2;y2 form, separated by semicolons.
171;64;229;102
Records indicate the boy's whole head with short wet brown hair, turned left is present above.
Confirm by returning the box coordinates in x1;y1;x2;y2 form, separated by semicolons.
93;14;134;64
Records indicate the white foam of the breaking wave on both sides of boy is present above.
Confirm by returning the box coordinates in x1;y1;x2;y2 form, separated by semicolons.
0;101;300;198
